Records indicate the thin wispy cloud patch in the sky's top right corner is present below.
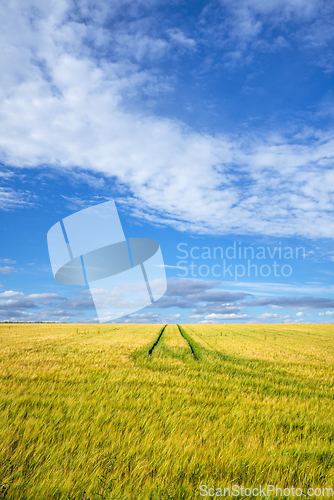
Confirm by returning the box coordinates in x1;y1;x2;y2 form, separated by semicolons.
201;0;334;66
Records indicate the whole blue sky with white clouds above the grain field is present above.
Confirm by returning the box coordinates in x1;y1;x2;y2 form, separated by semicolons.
0;0;334;324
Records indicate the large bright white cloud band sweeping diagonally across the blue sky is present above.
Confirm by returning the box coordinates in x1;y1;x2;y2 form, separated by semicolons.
0;0;334;238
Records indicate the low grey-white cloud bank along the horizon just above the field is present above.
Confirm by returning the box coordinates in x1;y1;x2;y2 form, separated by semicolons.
0;279;334;323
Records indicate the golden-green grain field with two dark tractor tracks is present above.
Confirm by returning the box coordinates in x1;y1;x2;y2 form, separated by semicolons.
0;324;334;500
